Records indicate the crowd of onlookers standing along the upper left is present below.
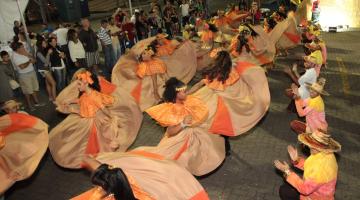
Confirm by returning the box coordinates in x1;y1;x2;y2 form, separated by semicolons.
0;0;268;110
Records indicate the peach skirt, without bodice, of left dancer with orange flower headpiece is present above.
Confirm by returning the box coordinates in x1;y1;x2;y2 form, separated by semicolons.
49;83;143;168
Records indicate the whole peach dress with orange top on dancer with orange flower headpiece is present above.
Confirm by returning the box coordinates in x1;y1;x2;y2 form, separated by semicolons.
49;85;143;168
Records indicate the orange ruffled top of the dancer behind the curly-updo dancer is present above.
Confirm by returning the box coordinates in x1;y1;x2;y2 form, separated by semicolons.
136;58;166;78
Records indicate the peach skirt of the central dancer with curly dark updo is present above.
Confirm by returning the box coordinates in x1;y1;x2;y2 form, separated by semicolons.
133;127;225;176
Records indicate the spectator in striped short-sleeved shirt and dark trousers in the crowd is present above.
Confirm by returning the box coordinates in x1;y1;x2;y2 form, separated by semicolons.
98;19;115;74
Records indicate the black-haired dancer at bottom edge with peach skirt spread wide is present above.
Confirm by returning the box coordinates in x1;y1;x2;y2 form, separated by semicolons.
71;153;209;200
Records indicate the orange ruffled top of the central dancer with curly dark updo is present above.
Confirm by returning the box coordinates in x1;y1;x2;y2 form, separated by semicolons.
146;96;208;127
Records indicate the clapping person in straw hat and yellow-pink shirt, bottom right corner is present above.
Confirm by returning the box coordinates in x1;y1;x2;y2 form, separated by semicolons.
274;130;341;200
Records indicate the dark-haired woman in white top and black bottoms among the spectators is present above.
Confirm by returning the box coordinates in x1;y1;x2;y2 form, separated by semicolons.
67;29;87;77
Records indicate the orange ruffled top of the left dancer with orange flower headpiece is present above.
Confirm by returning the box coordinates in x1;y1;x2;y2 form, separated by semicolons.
79;90;114;118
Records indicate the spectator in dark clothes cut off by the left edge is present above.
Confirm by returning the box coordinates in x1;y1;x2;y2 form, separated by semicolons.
0;51;14;105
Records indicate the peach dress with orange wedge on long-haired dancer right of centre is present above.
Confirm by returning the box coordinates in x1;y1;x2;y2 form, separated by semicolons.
193;62;270;136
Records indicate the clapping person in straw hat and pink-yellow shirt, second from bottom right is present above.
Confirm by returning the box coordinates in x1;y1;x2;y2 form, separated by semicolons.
290;78;329;134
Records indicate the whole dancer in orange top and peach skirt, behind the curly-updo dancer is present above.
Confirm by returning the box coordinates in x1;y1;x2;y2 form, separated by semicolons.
112;37;197;111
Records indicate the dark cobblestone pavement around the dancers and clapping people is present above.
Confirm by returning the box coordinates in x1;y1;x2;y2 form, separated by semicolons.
6;32;360;200
